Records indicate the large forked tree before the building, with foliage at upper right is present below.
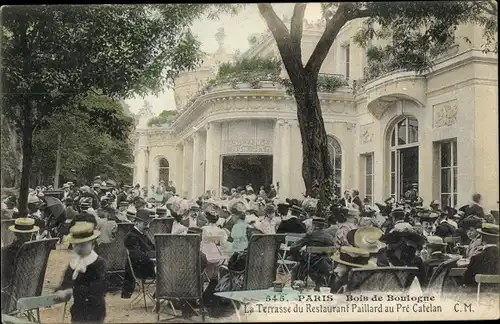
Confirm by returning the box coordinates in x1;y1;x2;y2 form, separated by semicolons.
257;1;492;203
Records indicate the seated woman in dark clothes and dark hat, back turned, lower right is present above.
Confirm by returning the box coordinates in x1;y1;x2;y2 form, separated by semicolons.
377;229;426;284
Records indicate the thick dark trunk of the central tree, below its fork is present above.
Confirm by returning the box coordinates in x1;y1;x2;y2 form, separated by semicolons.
294;75;332;201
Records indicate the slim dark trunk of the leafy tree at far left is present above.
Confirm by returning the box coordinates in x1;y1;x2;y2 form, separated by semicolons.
18;123;33;217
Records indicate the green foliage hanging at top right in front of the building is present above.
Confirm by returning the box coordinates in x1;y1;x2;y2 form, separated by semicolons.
354;1;490;79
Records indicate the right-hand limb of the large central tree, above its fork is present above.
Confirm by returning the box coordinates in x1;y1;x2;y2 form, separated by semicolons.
306;2;370;76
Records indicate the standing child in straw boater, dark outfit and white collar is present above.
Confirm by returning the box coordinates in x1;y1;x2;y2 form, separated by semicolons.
56;222;106;323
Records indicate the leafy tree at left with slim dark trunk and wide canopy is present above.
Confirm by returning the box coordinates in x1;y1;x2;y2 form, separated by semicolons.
1;4;217;215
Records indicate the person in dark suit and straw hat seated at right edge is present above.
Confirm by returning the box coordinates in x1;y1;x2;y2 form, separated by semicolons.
463;223;500;289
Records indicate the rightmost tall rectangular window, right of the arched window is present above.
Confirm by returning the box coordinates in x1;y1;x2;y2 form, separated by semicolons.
440;140;457;207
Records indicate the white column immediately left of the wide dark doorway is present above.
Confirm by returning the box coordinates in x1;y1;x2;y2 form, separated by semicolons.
205;122;221;195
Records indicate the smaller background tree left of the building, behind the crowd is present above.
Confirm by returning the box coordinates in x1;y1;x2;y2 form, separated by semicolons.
32;96;133;184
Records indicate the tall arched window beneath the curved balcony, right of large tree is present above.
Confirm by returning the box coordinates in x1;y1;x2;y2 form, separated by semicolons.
390;116;418;200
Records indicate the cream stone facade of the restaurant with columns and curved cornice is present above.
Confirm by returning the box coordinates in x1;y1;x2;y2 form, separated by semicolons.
134;21;499;211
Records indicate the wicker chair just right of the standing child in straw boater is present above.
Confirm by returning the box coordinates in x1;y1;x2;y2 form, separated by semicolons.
95;223;134;288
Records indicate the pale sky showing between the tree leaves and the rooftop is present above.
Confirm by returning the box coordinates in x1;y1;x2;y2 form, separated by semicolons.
125;3;321;115
